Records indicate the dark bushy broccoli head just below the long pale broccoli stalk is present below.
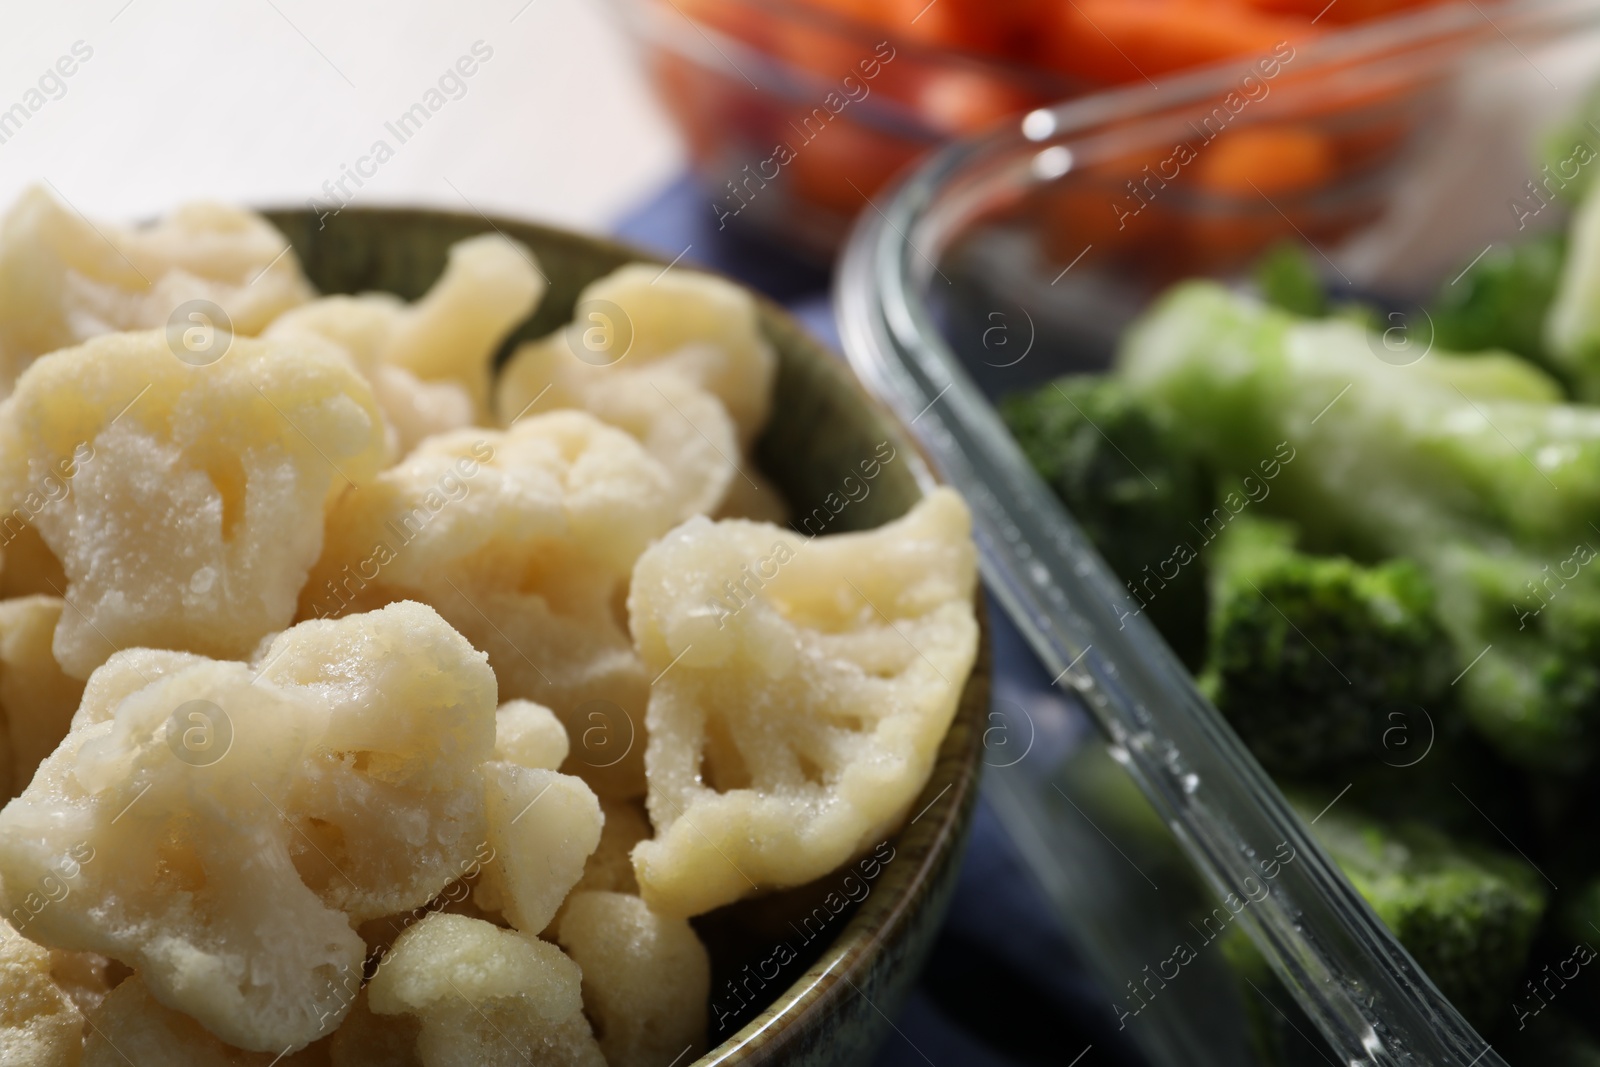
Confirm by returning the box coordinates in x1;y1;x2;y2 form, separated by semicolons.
1202;514;1454;774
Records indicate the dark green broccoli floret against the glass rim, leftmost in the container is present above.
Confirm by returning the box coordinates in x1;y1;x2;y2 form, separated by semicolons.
1002;374;1211;667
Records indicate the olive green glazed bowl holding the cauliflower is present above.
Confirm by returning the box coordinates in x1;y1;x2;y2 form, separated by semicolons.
266;208;990;1067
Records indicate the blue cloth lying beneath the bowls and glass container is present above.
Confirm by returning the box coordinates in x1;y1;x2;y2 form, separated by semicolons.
616;179;1139;1067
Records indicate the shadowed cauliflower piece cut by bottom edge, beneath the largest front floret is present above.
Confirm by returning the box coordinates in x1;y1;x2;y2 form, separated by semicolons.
83;974;328;1067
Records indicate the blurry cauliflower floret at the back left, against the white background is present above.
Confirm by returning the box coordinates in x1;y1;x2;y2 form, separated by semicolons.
0;187;312;395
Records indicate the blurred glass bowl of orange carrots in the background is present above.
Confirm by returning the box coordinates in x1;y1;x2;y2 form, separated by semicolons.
618;0;1472;258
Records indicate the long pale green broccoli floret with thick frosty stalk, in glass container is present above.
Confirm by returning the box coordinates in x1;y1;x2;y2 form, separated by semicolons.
1120;283;1600;771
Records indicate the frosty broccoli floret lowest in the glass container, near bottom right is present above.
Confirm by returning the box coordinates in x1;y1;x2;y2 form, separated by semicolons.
1299;801;1546;1030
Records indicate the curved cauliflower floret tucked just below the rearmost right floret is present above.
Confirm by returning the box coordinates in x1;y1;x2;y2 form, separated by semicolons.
498;346;739;522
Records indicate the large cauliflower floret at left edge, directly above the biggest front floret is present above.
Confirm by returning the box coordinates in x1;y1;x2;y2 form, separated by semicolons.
0;333;384;678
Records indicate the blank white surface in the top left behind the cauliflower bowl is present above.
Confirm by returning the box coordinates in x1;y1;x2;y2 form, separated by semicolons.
0;0;682;229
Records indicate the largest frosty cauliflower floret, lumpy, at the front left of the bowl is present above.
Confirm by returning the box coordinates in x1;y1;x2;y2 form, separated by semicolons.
0;603;494;1053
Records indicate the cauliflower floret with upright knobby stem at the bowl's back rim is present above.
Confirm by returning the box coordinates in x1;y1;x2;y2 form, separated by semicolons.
267;234;546;441
